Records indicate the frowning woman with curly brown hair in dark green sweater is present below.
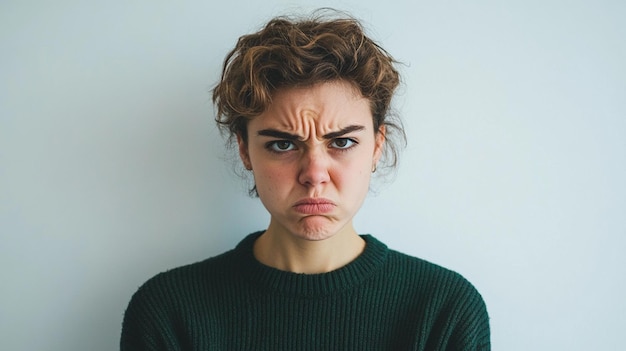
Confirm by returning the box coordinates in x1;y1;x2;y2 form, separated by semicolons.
121;11;490;351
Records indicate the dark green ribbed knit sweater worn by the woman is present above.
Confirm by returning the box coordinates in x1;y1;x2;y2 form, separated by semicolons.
121;233;490;351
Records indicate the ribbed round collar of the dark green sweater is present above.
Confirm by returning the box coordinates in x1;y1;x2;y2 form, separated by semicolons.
235;232;389;297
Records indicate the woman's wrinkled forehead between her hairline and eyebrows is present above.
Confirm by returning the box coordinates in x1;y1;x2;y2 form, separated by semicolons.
249;81;373;134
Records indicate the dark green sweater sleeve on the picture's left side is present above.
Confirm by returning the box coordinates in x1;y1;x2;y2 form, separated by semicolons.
120;278;181;351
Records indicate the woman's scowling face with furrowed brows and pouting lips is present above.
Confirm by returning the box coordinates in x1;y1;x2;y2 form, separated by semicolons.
239;81;385;240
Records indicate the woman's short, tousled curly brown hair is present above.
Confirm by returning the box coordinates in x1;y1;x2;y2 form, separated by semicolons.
213;10;405;167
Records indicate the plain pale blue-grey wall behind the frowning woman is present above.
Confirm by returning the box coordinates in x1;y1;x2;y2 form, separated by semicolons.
0;0;626;351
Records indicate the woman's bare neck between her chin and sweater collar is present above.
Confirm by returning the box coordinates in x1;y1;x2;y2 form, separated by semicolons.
254;224;365;274
